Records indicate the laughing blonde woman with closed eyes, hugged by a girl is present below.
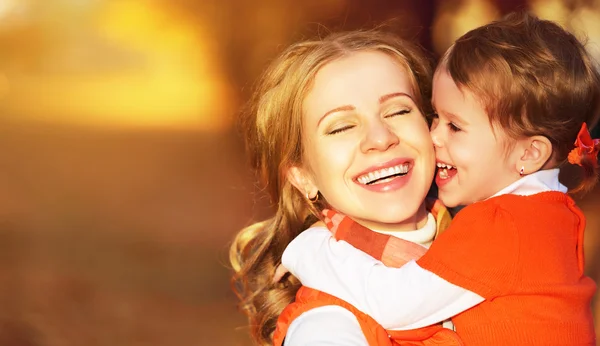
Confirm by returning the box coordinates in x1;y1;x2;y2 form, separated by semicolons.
230;31;450;345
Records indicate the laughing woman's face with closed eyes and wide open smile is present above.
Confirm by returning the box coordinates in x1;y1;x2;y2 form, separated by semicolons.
290;51;435;230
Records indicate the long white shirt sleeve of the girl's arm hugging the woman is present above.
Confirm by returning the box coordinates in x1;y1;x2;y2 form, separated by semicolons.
282;228;484;329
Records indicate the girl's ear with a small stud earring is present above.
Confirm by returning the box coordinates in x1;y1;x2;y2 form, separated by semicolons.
515;136;552;175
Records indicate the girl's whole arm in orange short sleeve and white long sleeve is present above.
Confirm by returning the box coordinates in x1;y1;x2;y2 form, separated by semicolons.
282;203;522;329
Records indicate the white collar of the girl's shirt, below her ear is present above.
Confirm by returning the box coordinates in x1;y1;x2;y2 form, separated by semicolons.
490;168;568;198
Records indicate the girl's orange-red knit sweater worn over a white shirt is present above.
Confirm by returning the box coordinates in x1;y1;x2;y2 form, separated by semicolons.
336;192;596;346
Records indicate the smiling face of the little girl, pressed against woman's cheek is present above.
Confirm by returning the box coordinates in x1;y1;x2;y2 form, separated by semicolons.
431;68;519;207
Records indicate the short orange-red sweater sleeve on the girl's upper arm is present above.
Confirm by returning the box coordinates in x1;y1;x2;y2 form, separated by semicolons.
417;201;520;299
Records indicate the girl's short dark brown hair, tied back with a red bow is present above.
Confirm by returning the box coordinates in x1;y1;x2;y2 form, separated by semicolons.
440;12;600;193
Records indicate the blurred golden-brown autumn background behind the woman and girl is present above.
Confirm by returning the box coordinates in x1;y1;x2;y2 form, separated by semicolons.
0;0;600;346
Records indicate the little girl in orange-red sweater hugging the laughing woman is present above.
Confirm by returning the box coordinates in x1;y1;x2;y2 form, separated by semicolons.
282;14;600;345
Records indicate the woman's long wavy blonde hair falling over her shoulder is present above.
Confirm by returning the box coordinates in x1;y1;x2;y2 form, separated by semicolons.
229;30;432;345
